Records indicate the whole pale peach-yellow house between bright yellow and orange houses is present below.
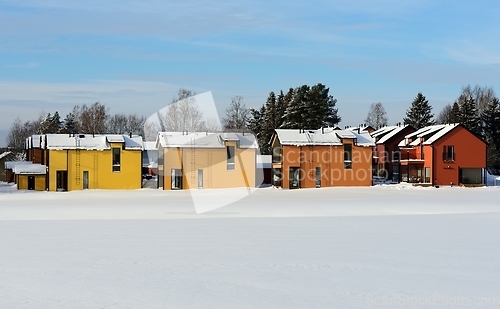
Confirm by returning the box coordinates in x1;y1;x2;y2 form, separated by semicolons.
156;132;258;190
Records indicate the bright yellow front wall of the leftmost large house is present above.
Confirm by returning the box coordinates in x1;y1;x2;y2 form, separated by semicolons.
49;143;142;191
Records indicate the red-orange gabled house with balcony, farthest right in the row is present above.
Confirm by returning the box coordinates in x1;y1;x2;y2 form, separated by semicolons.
399;124;487;186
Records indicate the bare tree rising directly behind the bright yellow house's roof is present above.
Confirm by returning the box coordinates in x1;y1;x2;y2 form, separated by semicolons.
73;102;109;134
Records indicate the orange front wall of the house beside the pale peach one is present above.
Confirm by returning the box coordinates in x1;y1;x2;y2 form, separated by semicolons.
281;140;372;189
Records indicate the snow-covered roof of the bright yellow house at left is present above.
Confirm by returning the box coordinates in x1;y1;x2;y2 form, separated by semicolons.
33;134;143;150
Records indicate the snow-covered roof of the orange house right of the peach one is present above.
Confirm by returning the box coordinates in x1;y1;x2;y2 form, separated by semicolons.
275;128;375;146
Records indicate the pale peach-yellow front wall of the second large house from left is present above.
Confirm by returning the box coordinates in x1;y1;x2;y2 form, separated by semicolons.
163;143;256;190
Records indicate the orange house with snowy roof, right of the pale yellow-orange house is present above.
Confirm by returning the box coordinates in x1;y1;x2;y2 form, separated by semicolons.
271;128;375;189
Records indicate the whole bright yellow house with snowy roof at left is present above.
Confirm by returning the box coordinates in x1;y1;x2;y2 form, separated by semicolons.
26;134;143;191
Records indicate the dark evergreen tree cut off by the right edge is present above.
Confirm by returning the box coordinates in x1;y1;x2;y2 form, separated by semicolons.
482;97;500;174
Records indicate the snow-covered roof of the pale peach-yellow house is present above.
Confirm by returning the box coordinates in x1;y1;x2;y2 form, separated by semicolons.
156;132;258;148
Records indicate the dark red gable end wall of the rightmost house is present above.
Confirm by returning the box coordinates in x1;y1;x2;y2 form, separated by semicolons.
433;126;486;185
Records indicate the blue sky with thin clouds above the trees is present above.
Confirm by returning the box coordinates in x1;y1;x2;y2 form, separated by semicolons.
0;0;500;146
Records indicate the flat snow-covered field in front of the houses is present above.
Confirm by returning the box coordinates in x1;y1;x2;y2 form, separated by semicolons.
0;184;500;308
